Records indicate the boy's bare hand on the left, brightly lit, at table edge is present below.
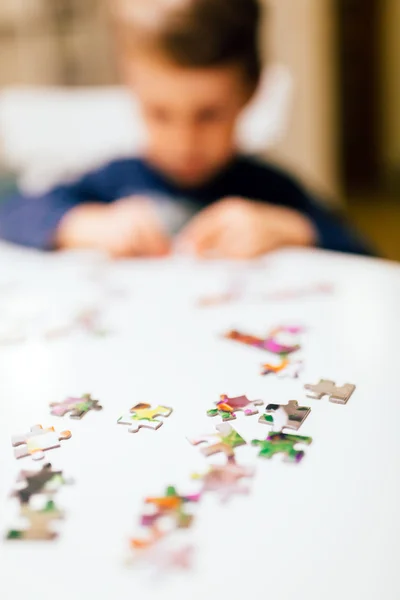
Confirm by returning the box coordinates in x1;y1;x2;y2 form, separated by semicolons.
56;197;171;258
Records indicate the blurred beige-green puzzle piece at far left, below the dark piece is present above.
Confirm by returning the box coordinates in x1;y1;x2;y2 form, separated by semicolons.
6;501;64;541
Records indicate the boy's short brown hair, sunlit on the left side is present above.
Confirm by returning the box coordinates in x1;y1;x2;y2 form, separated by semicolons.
110;0;261;84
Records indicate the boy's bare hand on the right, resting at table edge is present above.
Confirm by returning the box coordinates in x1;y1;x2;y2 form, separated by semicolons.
179;198;316;259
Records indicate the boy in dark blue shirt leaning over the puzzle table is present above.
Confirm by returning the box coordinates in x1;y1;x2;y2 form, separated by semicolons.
0;0;368;259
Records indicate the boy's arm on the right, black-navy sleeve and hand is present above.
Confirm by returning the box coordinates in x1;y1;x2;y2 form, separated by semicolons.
180;173;373;258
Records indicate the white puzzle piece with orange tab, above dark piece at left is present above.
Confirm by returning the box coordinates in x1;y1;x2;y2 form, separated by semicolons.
11;425;72;460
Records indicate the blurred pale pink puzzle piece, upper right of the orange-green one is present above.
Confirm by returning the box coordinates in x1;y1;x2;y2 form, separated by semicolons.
192;461;255;502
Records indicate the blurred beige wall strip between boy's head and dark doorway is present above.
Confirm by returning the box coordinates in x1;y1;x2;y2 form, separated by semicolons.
264;0;339;196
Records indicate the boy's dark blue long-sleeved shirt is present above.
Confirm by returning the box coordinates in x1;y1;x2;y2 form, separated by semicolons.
0;156;372;255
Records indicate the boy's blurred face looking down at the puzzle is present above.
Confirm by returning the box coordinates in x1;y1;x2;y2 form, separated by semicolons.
126;55;250;187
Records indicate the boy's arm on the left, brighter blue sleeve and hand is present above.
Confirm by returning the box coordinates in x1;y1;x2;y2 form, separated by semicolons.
0;165;170;256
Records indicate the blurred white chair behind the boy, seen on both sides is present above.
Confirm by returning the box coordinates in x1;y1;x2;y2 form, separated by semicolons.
0;66;292;193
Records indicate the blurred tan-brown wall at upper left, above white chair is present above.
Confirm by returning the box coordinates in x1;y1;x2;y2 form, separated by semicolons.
0;0;116;86
